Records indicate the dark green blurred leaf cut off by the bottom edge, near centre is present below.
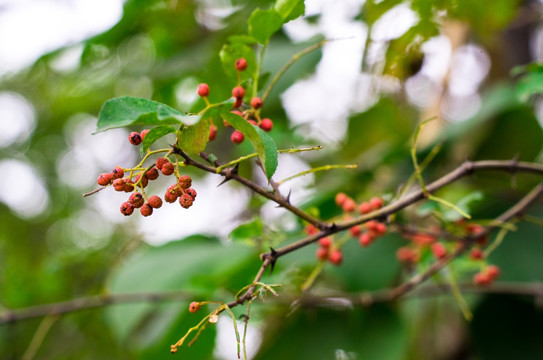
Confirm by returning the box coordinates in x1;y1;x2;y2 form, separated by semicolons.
256;303;408;360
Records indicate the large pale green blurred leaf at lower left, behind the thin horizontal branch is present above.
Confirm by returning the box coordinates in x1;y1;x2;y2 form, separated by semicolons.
108;236;253;339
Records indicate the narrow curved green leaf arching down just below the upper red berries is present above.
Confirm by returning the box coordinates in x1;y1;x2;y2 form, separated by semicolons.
221;112;277;180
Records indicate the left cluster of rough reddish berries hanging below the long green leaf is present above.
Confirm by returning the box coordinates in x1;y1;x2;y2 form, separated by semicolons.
96;129;196;216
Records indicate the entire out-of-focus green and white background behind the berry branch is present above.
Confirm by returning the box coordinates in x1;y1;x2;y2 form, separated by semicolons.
0;0;543;359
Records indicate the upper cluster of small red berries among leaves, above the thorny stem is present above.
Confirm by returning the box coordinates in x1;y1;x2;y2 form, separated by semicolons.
197;58;273;144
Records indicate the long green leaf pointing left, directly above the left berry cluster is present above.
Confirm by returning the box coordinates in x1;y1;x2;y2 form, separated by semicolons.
94;96;199;134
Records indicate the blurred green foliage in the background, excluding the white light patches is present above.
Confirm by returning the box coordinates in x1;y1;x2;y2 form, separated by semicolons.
0;0;543;360
